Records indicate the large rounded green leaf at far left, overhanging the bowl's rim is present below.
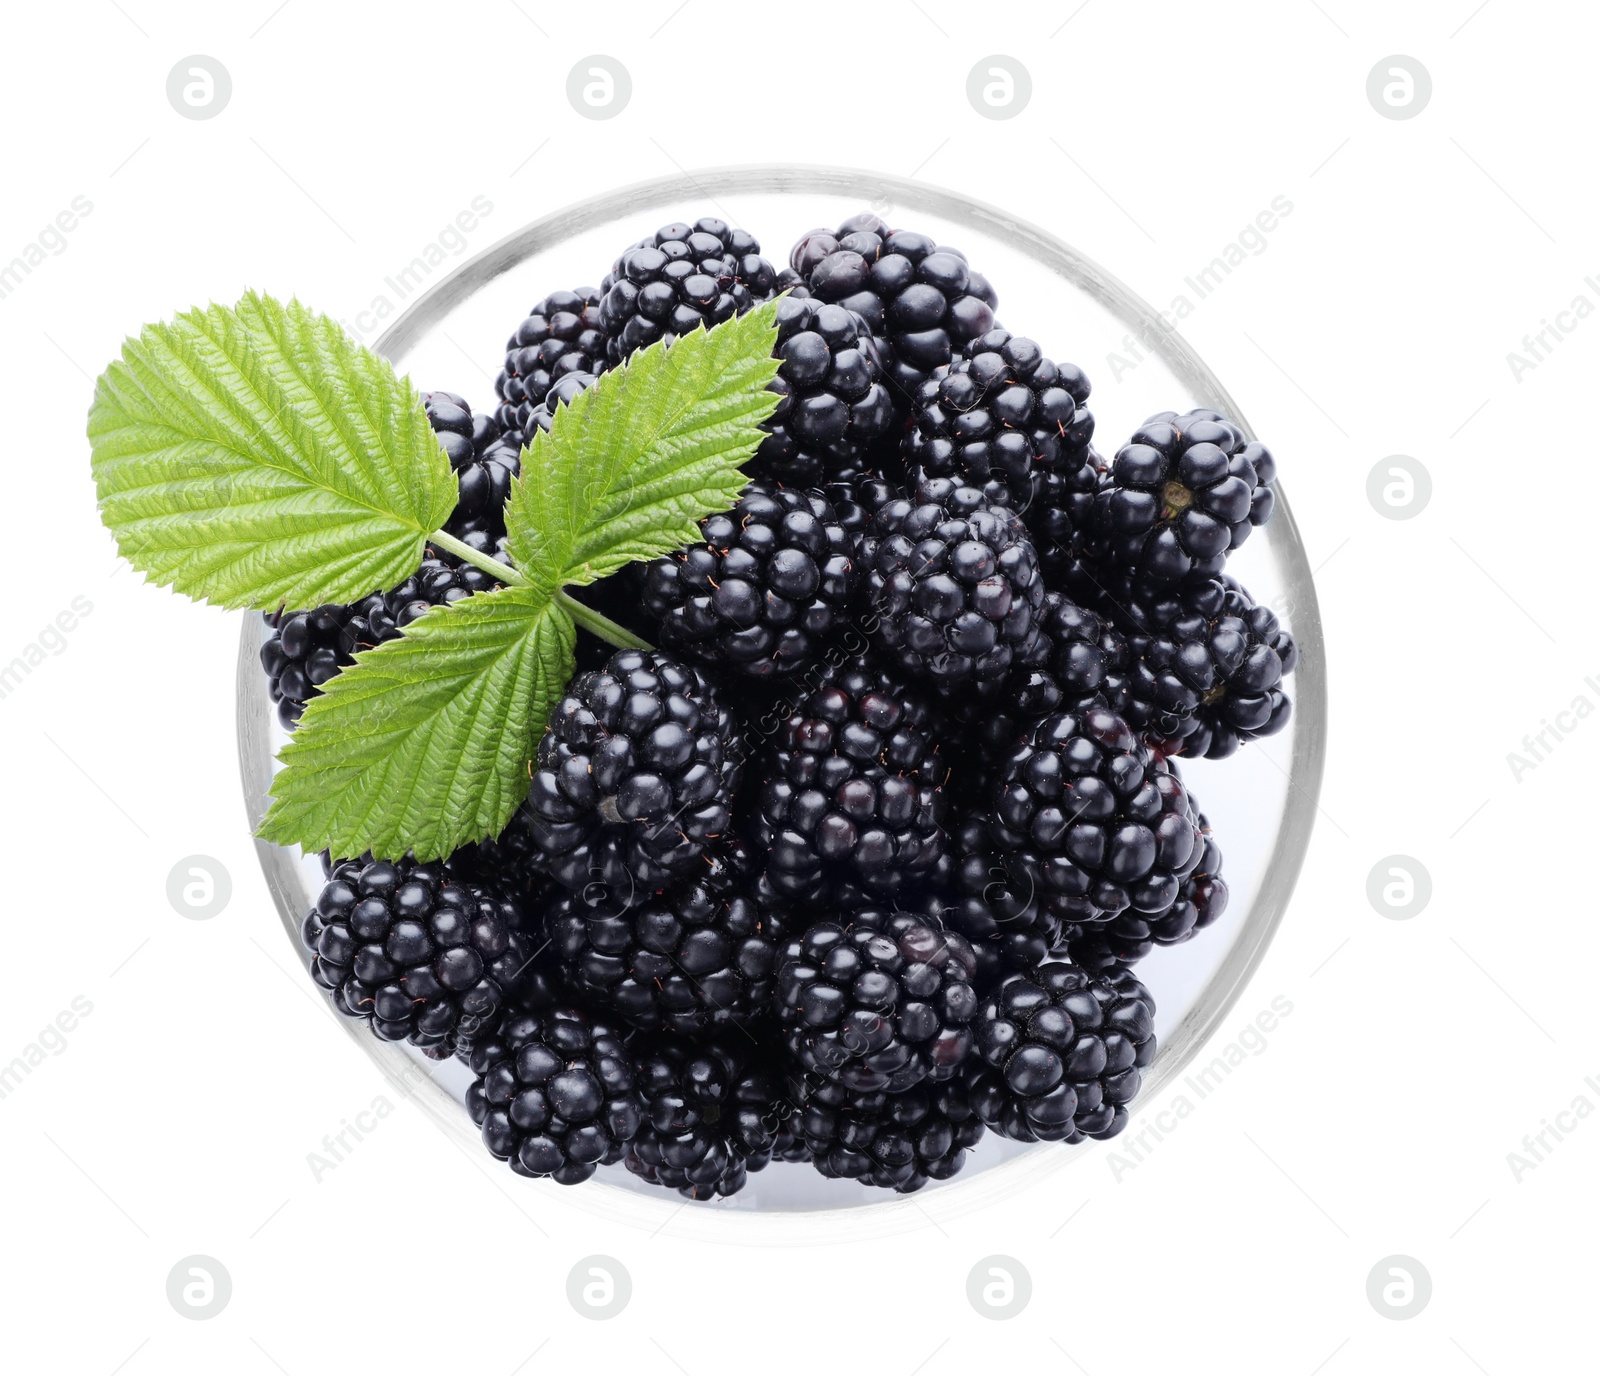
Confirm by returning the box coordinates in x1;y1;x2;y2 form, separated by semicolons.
88;293;458;608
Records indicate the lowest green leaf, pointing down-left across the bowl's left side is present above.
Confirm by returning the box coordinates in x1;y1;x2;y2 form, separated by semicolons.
259;587;574;859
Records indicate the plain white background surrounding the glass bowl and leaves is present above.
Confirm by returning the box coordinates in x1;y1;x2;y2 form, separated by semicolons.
0;0;1600;1376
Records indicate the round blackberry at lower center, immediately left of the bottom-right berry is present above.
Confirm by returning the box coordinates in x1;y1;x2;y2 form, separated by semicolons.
774;910;978;1093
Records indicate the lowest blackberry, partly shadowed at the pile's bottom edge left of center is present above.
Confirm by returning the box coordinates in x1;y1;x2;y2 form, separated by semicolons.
622;1038;794;1200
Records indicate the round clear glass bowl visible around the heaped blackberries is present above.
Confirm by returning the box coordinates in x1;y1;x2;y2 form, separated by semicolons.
238;166;1328;1245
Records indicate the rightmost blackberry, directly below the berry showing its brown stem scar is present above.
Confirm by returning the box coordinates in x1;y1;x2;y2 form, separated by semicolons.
1107;576;1299;758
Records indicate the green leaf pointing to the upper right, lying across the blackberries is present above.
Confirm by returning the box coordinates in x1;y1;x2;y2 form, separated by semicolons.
506;301;778;592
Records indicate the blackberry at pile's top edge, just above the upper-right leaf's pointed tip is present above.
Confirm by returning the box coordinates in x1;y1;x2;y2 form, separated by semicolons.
600;216;778;365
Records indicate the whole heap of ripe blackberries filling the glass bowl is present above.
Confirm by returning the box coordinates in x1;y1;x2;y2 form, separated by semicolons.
272;214;1298;1198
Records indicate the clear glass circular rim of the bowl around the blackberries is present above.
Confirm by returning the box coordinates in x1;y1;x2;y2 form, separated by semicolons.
235;163;1328;1246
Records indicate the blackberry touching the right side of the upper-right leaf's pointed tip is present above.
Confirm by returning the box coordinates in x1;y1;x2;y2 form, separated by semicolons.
752;296;894;486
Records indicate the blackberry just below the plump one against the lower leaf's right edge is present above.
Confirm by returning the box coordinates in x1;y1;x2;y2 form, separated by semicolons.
546;840;789;1034
